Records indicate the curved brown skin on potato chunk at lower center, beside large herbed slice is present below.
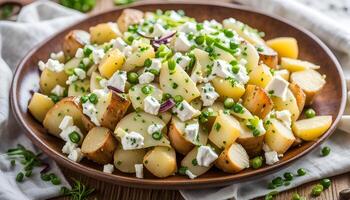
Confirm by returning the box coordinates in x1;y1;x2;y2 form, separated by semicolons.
168;118;194;155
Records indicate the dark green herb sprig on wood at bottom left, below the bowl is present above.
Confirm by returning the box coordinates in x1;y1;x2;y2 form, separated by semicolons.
61;179;95;200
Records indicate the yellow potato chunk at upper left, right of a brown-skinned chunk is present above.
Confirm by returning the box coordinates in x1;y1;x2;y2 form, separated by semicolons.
89;22;122;44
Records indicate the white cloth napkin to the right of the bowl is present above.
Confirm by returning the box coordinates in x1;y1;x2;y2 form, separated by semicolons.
180;0;350;200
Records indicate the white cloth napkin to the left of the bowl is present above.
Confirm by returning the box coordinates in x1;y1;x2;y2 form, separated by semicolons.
0;1;84;200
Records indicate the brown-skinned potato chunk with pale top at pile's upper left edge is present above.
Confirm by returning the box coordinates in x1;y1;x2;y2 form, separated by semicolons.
63;30;90;57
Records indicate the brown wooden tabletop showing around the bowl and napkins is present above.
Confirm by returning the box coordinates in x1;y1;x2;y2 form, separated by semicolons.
44;0;350;200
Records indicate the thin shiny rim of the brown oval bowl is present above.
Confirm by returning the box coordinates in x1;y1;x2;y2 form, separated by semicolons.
10;0;346;189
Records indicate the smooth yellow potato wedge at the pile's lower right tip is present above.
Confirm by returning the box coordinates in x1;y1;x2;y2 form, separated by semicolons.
292;115;332;141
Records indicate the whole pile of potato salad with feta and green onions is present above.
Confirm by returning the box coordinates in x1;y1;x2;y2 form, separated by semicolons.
28;9;332;179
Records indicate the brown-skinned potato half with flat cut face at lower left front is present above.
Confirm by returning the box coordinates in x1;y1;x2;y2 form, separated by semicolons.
81;127;117;165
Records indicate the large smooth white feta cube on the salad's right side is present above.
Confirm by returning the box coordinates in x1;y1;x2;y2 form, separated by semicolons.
265;76;289;100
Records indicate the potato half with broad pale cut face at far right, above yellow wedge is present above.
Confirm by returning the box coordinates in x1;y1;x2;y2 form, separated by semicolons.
290;69;326;105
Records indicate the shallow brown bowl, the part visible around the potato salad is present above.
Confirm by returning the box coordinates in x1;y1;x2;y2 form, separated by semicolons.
11;2;345;189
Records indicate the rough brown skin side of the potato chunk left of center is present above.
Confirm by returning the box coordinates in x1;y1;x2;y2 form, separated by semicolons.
101;92;130;130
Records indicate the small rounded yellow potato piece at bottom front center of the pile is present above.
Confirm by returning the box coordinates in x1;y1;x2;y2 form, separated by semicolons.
143;146;177;178
